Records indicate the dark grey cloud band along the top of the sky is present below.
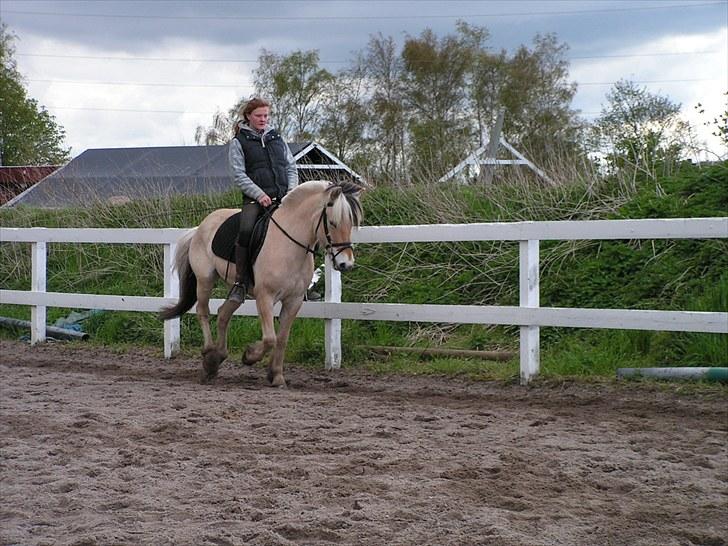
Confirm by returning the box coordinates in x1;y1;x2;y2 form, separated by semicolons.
0;0;726;62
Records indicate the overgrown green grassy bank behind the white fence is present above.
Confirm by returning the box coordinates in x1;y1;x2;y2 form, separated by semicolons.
0;158;728;381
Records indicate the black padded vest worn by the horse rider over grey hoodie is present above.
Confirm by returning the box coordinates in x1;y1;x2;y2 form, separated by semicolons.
235;130;288;199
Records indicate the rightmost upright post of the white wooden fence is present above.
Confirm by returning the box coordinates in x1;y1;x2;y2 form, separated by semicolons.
519;240;540;385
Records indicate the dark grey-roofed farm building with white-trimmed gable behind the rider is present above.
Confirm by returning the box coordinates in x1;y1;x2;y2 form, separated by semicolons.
4;142;362;208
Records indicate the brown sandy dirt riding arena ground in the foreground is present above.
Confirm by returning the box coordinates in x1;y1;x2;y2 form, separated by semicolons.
0;341;728;546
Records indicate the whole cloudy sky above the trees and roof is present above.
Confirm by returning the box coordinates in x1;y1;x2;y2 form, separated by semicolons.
0;0;728;157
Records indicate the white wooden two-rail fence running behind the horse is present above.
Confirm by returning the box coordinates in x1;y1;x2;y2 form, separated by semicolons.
0;217;728;384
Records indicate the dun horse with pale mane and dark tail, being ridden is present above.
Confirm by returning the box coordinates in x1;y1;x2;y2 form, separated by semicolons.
159;180;362;387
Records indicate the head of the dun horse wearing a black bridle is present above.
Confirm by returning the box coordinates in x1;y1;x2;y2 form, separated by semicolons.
317;182;362;271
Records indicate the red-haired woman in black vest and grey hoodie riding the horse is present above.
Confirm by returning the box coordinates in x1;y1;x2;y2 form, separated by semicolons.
228;98;298;303
